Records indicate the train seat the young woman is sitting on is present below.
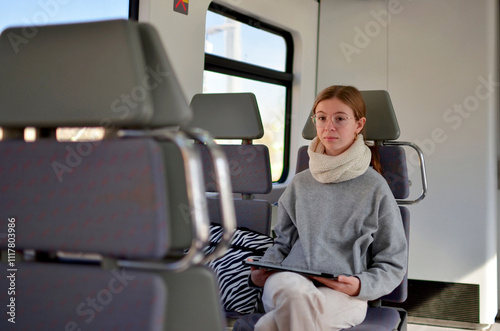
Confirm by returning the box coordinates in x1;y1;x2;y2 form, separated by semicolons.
233;91;427;331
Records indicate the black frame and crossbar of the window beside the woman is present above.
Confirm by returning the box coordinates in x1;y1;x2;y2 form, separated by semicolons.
205;0;294;183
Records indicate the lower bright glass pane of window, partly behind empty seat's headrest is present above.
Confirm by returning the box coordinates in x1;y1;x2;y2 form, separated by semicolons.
203;71;286;181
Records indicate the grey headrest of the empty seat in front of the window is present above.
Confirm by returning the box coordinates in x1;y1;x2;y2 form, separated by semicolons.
188;93;264;139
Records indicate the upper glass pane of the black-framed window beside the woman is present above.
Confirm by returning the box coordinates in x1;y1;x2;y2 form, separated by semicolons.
205;11;286;71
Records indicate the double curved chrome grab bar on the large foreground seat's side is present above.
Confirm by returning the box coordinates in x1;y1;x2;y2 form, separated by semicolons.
116;128;236;271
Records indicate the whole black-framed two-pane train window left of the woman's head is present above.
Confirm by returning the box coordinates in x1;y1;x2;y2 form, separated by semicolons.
203;3;293;182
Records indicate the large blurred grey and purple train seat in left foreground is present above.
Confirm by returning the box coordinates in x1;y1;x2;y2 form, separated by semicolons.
0;20;234;331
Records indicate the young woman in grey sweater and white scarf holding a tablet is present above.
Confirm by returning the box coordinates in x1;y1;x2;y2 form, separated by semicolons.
250;86;407;331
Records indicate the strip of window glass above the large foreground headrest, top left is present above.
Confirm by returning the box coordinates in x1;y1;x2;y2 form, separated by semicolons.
0;0;129;32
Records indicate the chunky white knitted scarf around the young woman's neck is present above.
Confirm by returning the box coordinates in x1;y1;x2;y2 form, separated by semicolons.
307;134;372;183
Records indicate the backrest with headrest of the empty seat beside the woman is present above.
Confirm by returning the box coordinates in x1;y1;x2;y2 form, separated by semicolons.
189;93;272;234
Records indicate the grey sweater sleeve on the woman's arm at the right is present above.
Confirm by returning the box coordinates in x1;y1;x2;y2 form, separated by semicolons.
355;196;408;300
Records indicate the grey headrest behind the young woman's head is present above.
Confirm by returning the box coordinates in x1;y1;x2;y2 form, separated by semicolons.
302;90;400;141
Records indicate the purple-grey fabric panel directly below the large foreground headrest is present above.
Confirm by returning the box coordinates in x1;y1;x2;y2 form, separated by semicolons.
0;139;169;259
